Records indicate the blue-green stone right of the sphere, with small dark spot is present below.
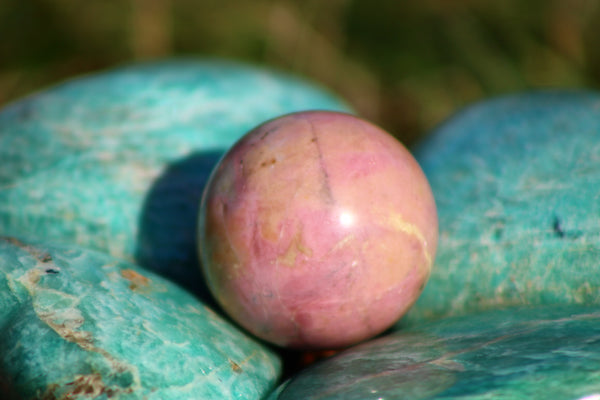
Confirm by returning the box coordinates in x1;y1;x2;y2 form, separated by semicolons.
403;91;600;324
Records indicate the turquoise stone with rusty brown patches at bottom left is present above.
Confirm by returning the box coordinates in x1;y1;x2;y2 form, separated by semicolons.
0;237;281;400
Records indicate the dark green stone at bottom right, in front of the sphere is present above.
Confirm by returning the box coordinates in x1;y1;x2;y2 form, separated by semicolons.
269;305;600;400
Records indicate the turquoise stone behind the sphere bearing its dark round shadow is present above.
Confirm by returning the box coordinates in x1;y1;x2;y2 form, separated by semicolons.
0;59;348;296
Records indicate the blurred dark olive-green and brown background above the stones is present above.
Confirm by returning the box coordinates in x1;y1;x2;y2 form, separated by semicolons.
0;0;600;145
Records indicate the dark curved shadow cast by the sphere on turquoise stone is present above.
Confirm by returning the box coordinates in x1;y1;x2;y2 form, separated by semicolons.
136;151;223;307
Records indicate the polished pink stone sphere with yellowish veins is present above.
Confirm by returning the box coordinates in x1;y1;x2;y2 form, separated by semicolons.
199;111;438;349
